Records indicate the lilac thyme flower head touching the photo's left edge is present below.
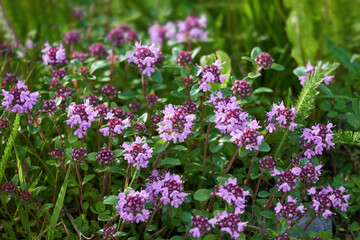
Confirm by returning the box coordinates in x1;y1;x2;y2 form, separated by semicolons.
1;80;39;113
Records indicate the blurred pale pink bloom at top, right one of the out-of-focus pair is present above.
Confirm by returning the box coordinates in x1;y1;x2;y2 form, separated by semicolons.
176;15;208;42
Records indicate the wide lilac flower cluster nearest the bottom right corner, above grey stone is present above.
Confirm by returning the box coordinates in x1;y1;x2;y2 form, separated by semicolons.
308;186;350;219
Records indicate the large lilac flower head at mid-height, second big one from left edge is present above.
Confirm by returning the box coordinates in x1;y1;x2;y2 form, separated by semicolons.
65;101;98;138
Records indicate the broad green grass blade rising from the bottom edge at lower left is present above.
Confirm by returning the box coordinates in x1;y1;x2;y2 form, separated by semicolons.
46;167;70;240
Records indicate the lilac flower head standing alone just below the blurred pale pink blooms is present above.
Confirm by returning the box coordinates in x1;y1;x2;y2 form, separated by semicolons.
127;42;160;77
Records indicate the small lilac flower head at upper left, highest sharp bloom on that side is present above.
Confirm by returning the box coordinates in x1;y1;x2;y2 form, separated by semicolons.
41;42;67;68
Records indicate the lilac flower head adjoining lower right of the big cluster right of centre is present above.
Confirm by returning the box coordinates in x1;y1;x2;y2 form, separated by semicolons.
230;120;264;150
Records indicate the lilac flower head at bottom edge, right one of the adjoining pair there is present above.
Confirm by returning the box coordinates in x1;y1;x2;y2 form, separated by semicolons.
209;211;247;239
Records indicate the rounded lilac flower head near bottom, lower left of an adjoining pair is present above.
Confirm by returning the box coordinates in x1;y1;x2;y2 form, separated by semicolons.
115;189;150;223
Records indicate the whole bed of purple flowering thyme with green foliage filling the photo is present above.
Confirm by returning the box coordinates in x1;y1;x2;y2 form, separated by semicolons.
0;1;360;240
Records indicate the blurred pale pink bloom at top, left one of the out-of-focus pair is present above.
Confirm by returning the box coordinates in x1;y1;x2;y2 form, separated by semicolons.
148;22;176;44
